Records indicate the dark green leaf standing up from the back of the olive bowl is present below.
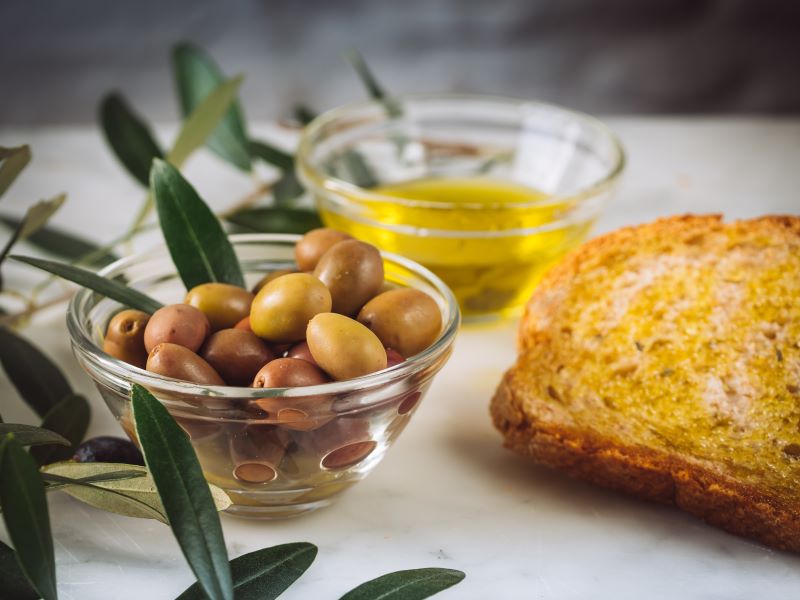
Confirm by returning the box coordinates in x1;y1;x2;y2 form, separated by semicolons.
150;160;245;289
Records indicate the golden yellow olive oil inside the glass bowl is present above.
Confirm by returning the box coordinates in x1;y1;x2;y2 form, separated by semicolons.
322;177;592;320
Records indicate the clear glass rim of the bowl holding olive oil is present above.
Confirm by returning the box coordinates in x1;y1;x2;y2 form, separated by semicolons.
295;92;627;213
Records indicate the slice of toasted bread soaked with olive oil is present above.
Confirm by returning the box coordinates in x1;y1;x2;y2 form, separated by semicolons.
491;216;800;552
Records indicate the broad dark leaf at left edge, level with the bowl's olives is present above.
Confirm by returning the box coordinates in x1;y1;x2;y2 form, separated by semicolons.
0;327;72;417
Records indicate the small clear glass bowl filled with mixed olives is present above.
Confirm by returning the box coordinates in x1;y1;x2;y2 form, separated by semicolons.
67;229;460;519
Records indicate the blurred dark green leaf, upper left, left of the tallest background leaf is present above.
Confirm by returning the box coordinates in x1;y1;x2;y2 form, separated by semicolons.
100;92;164;187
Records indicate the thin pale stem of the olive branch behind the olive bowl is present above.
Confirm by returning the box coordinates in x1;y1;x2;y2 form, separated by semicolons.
0;182;275;327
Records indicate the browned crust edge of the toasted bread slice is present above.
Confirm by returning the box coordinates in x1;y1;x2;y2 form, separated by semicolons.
490;215;800;552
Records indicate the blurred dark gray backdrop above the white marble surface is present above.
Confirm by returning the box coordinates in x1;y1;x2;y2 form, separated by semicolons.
0;0;800;125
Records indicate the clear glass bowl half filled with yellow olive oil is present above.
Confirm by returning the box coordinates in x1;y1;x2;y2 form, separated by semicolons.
297;94;625;321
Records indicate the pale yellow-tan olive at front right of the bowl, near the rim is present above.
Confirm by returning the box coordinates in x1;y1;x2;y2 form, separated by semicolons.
306;313;387;381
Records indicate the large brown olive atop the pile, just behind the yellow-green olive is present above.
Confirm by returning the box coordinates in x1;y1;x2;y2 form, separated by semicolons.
314;240;383;316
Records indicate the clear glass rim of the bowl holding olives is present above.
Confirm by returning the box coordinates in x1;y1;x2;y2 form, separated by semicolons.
66;233;461;406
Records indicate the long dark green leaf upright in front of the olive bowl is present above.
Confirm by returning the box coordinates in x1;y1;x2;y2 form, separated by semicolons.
131;384;233;600
